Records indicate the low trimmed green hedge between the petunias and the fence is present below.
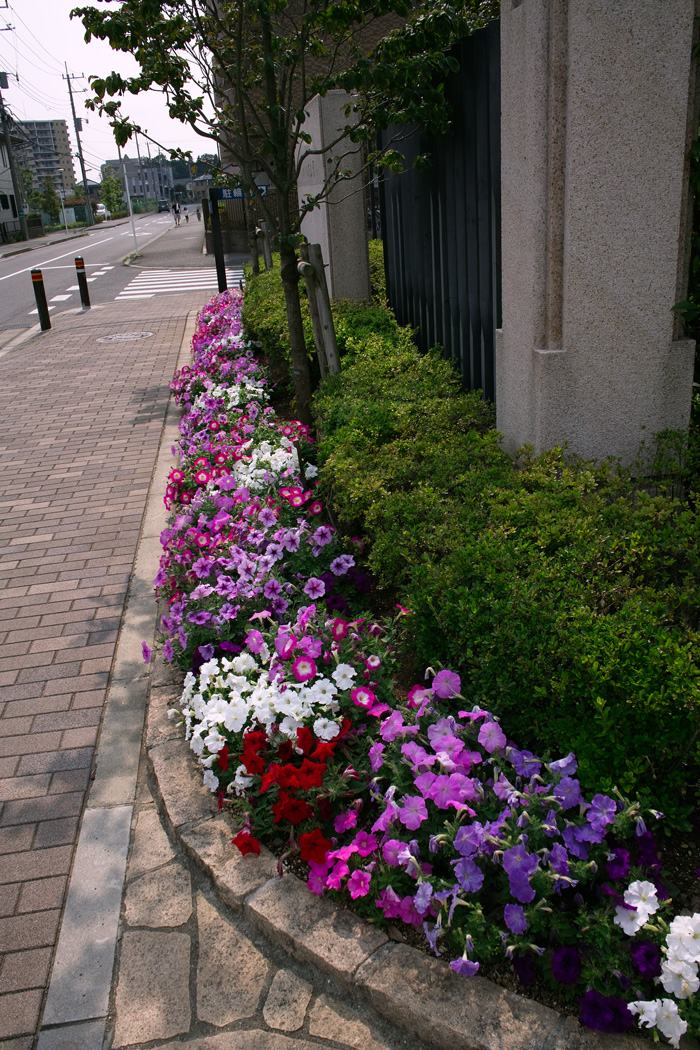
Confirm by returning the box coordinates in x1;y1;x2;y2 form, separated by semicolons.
247;245;700;826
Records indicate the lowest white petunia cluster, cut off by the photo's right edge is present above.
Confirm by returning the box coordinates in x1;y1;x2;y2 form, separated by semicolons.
625;915;700;1047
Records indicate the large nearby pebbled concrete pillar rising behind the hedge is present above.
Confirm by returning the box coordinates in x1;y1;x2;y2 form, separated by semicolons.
496;0;698;463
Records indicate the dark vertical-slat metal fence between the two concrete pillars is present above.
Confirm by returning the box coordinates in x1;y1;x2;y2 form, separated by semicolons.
380;22;501;400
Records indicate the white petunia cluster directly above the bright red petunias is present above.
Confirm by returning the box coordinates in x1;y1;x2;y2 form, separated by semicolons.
181;644;348;795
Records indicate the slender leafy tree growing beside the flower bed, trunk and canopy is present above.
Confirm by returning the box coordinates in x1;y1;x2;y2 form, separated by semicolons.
71;0;499;421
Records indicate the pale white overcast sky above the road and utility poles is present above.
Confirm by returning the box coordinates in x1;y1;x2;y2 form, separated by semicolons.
0;0;211;181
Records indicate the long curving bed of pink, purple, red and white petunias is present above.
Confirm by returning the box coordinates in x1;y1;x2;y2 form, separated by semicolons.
156;293;700;1046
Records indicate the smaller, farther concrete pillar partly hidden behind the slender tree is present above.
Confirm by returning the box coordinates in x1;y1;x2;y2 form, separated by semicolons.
298;90;369;299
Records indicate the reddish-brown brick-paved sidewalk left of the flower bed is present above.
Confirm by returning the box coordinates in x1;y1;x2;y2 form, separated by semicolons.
0;294;208;1050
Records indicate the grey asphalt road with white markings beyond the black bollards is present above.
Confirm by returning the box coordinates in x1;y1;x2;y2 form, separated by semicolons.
0;213;178;330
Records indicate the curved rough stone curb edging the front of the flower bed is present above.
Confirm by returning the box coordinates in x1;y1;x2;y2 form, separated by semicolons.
146;654;649;1050
